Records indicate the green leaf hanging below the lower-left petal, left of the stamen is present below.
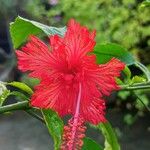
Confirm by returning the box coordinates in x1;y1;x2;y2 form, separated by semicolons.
42;109;63;150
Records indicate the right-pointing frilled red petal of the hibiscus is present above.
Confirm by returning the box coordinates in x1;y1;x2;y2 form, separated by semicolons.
91;58;125;96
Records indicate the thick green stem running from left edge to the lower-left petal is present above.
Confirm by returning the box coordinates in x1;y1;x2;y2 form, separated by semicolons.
0;101;29;114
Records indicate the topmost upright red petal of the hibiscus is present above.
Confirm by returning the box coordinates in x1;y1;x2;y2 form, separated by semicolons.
64;19;96;62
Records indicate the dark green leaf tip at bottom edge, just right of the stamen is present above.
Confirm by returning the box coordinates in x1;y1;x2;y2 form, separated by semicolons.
82;137;103;150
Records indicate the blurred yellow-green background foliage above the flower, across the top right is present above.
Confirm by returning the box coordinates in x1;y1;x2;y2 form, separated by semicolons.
26;0;150;64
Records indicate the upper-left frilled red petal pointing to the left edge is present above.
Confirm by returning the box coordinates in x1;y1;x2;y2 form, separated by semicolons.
16;36;52;78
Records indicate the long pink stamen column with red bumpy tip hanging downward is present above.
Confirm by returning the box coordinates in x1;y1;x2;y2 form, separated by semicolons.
61;83;86;150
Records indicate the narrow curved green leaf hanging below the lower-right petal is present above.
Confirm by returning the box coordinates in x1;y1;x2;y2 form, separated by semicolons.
97;122;120;150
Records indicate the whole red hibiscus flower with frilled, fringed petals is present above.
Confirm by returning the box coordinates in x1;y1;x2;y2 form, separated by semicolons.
16;19;124;150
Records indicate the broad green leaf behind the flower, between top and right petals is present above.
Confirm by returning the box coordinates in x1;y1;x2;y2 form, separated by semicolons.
94;43;135;65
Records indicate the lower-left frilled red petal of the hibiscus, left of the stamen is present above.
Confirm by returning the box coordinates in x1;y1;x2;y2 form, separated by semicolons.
31;80;76;116
